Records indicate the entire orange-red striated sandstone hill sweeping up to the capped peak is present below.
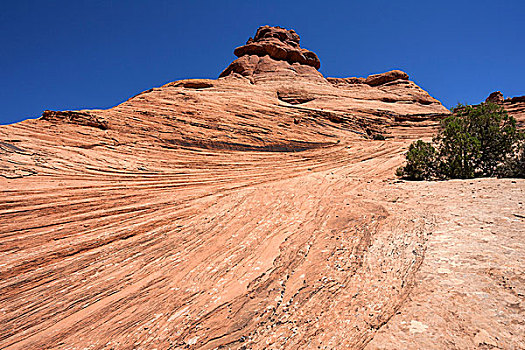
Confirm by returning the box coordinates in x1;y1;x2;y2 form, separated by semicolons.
0;27;525;349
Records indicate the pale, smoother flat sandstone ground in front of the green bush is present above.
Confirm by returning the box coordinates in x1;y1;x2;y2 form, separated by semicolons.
363;179;525;350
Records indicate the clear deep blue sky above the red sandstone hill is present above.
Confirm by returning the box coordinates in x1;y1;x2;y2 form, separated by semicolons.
0;0;525;124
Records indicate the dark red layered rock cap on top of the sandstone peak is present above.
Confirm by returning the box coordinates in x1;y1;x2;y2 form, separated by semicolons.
233;26;321;69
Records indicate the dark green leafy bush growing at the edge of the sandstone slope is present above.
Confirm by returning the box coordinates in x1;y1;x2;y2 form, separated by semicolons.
396;103;525;180
